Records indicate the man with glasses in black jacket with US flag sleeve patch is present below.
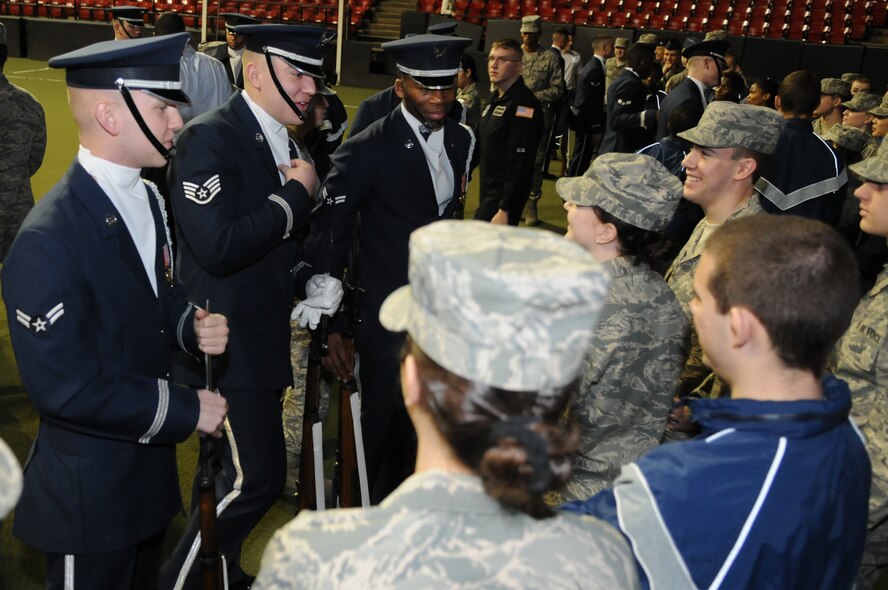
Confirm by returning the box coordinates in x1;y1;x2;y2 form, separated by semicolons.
475;39;543;225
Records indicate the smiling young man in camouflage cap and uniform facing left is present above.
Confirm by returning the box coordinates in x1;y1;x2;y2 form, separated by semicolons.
666;101;784;402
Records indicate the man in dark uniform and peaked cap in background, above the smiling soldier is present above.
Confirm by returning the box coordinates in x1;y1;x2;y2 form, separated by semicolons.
657;39;729;141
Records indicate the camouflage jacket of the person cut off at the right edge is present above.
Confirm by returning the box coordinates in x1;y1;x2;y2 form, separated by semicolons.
831;267;888;511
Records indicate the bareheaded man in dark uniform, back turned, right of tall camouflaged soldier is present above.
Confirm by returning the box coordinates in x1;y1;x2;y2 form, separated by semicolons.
568;35;614;176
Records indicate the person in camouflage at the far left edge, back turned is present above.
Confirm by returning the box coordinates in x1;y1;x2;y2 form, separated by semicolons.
0;23;46;264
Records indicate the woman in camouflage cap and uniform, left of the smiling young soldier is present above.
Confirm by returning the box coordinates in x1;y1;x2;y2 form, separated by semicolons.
555;153;689;500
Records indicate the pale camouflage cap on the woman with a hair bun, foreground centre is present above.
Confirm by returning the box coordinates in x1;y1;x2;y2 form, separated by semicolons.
379;220;608;391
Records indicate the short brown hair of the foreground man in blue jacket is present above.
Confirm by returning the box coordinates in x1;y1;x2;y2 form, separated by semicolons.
704;214;858;375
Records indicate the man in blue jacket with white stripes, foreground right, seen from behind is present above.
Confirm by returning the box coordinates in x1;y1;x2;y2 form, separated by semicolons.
565;215;870;590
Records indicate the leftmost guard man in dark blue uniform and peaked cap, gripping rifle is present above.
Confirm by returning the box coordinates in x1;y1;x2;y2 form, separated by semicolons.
3;34;228;590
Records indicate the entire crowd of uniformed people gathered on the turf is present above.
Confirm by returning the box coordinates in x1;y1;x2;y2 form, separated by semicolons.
0;12;888;589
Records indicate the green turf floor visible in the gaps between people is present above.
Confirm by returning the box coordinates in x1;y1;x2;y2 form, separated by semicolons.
0;58;566;590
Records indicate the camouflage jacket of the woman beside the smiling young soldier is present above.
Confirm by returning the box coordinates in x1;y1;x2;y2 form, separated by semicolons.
563;257;689;500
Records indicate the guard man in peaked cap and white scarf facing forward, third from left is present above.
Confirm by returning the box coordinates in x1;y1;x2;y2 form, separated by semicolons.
306;35;474;503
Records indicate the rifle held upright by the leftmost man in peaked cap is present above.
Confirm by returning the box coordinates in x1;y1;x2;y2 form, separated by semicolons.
197;300;223;590
